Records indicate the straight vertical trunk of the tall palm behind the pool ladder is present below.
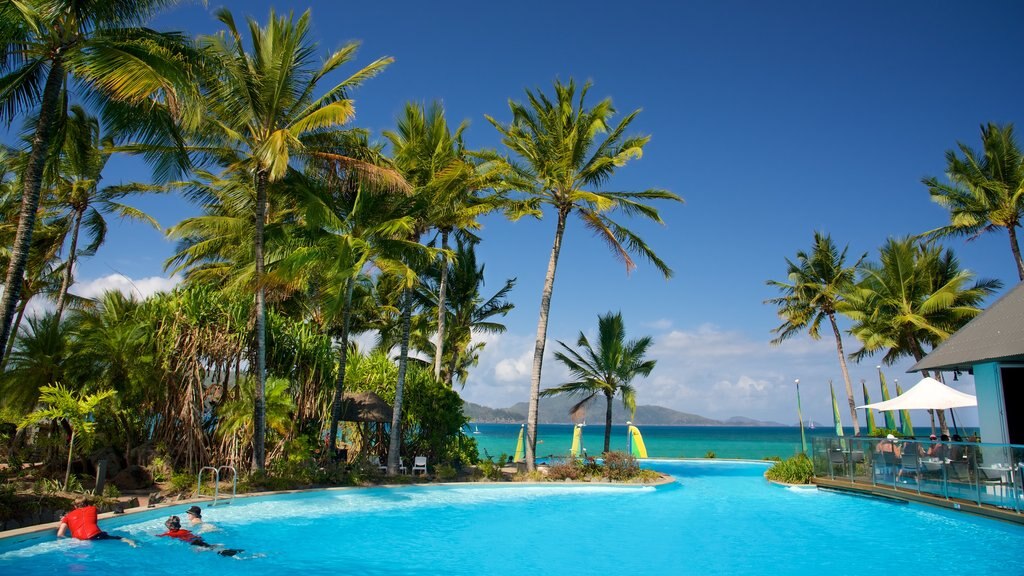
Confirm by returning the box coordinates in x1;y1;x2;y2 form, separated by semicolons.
253;170;270;470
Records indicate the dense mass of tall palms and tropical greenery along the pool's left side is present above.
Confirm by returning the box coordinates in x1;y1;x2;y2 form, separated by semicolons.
0;0;679;484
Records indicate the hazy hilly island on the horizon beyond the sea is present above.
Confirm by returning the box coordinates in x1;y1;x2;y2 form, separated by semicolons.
463;397;785;426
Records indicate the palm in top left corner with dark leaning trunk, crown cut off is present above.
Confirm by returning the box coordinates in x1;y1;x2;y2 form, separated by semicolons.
0;0;195;349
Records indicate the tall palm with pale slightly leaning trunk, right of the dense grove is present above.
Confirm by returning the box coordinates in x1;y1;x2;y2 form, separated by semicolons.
486;80;682;470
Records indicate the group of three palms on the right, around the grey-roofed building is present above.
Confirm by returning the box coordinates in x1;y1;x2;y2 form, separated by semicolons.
766;124;1024;434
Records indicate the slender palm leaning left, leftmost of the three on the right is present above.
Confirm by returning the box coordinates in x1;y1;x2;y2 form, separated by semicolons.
765;232;866;436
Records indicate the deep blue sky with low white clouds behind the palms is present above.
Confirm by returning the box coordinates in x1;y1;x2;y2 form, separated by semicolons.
36;1;1024;423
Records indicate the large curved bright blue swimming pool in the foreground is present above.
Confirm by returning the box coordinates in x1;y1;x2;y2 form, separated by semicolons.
0;460;1024;576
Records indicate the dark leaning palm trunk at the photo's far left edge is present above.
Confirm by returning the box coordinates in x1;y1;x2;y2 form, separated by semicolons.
0;56;65;349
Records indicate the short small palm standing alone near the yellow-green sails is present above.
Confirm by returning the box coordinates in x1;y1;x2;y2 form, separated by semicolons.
541;312;657;452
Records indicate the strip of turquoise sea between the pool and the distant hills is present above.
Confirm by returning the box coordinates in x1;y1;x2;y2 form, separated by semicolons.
467;422;963;459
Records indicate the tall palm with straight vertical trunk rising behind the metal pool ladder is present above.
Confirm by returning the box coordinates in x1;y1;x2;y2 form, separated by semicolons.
199;8;391;469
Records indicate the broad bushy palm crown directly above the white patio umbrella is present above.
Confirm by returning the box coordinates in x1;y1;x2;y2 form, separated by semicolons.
839;238;1002;434
